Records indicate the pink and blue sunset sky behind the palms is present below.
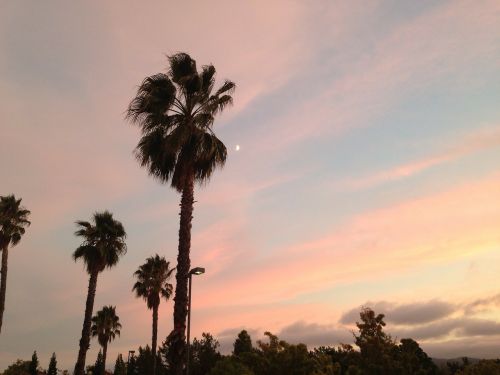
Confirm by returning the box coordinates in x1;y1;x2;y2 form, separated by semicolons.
0;0;500;369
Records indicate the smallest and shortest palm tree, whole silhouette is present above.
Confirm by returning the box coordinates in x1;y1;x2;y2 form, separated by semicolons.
91;306;122;375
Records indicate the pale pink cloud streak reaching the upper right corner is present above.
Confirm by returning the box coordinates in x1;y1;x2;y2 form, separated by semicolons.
252;0;498;157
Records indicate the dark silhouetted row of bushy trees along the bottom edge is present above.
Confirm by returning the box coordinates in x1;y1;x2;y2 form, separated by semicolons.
3;308;500;375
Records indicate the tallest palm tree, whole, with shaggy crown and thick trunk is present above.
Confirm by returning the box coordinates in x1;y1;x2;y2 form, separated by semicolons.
127;53;235;375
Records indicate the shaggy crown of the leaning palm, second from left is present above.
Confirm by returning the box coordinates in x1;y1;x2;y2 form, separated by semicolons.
73;211;127;273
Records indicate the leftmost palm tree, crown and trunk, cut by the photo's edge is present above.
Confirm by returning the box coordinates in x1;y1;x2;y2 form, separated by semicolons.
0;195;31;332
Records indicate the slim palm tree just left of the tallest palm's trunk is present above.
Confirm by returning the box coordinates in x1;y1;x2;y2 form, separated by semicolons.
132;254;174;375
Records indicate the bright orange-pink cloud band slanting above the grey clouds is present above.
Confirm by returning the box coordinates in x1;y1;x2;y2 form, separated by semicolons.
191;175;500;314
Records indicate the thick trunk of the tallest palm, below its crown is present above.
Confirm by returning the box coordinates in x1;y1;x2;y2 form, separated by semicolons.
171;173;194;375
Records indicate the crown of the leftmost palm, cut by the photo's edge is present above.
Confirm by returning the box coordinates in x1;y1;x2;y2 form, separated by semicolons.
0;195;31;251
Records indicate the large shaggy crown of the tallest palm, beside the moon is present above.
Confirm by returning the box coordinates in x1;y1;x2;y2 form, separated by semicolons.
127;53;235;192
